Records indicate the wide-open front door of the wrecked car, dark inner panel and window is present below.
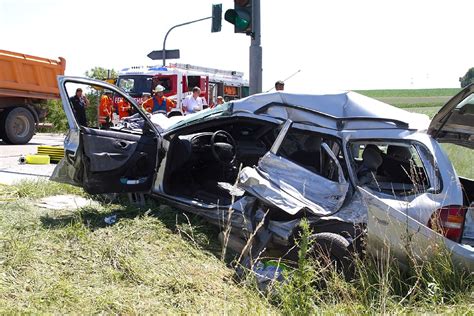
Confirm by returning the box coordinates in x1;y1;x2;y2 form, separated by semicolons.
51;76;161;194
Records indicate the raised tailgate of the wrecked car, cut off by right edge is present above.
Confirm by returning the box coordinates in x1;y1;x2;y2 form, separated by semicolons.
428;84;474;149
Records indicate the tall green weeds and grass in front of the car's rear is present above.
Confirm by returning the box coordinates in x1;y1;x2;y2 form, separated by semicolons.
275;221;474;315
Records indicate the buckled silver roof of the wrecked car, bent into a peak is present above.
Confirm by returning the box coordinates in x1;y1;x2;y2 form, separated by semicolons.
233;91;430;130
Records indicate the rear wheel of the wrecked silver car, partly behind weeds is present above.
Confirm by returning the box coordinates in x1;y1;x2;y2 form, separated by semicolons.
309;233;354;279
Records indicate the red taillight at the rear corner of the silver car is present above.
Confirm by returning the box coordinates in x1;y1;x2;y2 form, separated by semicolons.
428;205;466;242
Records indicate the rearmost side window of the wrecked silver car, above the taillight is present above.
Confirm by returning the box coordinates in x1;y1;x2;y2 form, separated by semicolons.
348;141;440;195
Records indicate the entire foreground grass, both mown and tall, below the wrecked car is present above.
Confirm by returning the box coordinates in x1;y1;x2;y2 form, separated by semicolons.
0;182;474;315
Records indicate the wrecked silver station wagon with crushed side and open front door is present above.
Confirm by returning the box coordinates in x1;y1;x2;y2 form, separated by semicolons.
53;77;474;271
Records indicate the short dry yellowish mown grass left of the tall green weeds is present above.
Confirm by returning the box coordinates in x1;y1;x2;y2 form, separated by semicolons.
0;182;273;314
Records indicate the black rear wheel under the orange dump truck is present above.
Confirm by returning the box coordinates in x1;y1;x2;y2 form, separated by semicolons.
0;107;35;145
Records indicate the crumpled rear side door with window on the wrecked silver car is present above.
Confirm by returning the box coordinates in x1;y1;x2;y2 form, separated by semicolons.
258;120;349;213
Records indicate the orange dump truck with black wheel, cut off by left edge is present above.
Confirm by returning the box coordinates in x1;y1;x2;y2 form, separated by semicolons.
0;50;66;144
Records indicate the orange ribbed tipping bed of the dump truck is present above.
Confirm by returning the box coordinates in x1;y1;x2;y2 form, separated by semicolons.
0;50;66;99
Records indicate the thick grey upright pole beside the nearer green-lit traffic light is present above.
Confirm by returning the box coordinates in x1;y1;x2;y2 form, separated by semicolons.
249;0;262;94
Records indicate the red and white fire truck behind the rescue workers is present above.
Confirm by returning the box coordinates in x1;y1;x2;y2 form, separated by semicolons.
117;63;249;111
